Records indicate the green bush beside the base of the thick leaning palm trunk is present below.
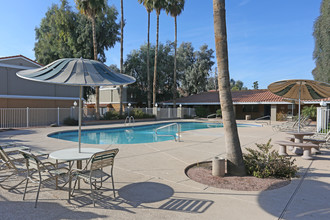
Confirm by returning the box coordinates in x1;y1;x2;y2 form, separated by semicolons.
243;139;298;178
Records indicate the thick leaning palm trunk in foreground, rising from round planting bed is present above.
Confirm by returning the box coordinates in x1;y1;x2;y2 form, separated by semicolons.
213;0;246;176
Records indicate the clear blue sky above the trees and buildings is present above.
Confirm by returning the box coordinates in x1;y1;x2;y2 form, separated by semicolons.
0;0;321;89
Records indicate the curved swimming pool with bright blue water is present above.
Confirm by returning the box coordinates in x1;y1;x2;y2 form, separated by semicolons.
48;122;260;144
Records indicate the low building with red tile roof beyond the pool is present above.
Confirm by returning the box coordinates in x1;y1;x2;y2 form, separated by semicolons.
163;89;330;121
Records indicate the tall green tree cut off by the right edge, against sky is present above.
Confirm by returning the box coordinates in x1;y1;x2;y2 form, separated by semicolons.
312;0;330;83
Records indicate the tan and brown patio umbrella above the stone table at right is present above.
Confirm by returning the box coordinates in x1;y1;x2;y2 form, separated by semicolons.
268;79;330;132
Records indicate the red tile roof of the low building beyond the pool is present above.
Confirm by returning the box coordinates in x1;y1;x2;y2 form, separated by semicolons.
163;89;330;105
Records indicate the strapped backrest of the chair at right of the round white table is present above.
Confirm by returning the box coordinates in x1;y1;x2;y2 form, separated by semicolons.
90;148;119;170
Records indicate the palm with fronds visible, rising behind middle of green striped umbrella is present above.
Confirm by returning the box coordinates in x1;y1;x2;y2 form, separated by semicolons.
75;0;106;119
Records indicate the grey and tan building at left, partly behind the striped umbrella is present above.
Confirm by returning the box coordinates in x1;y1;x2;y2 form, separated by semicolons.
0;55;79;108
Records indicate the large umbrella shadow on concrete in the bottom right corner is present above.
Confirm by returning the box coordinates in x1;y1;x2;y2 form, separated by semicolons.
258;180;330;219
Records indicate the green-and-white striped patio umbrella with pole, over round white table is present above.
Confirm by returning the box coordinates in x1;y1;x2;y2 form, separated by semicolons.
16;58;135;152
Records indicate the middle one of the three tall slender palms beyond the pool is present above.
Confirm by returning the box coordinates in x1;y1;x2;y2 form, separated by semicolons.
152;0;166;106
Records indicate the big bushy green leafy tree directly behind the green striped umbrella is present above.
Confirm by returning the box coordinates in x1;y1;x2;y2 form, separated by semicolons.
34;0;119;100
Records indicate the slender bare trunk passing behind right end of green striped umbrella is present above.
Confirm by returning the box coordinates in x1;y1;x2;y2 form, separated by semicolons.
119;0;124;115
